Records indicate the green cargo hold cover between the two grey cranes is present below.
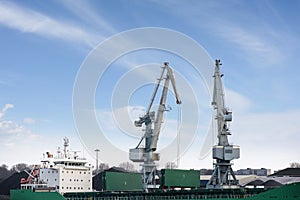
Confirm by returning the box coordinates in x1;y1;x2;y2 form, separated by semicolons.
161;169;200;188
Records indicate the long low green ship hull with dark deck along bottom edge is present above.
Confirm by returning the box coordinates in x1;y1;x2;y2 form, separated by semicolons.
10;183;300;200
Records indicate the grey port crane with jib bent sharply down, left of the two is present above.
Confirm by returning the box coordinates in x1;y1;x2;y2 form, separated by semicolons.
129;62;181;191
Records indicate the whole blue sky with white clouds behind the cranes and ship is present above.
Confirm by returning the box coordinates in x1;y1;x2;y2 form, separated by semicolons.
0;0;300;173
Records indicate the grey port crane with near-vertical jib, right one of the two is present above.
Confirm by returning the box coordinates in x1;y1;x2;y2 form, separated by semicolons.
206;60;240;189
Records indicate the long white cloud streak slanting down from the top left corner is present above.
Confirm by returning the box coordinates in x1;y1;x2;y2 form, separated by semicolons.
0;1;103;46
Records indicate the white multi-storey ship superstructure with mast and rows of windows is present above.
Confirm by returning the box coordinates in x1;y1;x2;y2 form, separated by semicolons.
22;138;92;194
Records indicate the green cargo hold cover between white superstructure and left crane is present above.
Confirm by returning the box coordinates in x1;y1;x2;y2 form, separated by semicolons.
103;172;143;191
